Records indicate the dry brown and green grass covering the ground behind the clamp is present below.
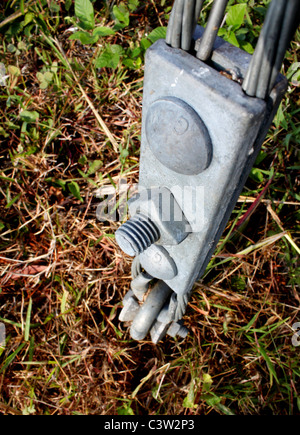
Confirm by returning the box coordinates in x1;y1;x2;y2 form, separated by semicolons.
0;0;300;415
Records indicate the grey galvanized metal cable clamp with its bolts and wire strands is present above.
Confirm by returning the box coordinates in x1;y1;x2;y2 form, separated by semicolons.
116;0;300;343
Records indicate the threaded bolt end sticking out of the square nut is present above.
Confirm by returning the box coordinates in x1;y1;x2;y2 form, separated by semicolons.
116;213;160;257
